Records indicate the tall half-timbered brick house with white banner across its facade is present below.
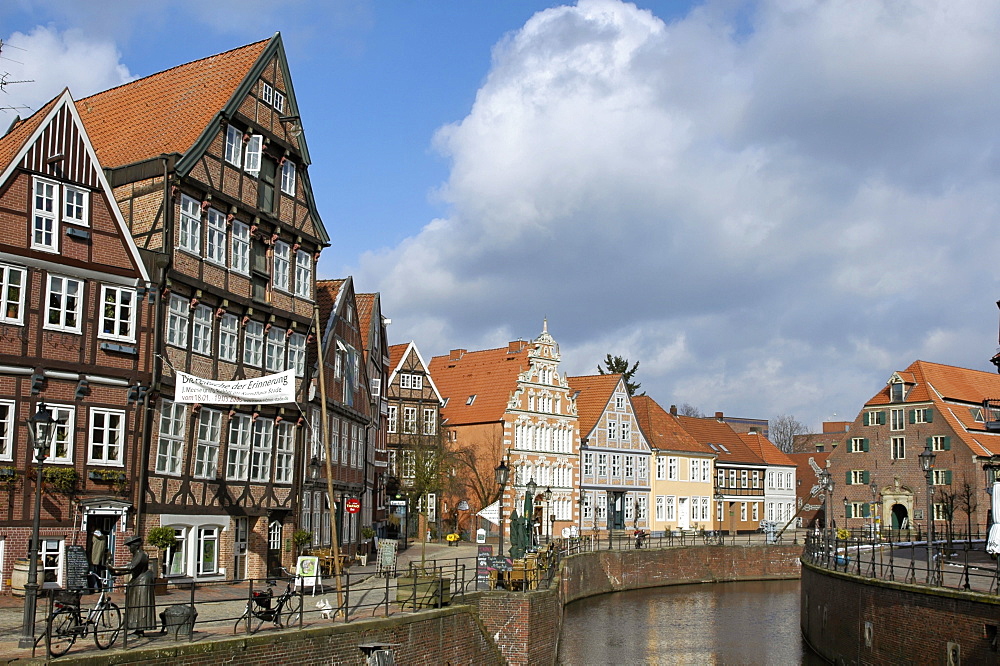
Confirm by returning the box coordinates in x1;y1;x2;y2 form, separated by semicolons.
77;35;328;579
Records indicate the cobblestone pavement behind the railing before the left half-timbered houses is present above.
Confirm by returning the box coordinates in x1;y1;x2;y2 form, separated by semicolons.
0;542;477;659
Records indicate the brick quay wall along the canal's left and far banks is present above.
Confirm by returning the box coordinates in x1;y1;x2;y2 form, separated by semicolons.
11;545;802;666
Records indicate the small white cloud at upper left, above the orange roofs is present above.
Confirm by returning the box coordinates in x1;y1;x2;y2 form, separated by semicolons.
0;26;132;115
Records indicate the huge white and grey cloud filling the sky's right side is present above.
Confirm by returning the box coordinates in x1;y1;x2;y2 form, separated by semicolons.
357;0;1000;427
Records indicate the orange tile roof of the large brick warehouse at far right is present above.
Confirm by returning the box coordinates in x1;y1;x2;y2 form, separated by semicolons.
865;360;1000;456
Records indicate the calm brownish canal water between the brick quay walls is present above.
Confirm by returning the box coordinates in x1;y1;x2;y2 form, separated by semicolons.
559;580;826;666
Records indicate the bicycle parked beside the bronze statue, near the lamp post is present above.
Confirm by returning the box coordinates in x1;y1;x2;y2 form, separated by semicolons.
43;588;122;657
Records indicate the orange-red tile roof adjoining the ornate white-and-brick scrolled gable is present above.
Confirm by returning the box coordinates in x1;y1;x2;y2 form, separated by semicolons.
429;342;532;426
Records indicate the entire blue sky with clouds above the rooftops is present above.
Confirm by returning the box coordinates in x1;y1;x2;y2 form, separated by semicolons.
0;0;1000;429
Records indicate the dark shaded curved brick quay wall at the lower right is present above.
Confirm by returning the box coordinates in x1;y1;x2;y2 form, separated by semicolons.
800;562;1000;665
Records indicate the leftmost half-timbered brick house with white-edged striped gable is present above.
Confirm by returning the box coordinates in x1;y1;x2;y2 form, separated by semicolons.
0;91;152;587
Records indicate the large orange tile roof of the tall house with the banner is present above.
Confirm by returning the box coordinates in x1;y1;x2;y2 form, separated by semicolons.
76;37;275;167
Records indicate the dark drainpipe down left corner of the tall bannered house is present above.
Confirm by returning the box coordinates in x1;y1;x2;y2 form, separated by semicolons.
135;154;174;540
